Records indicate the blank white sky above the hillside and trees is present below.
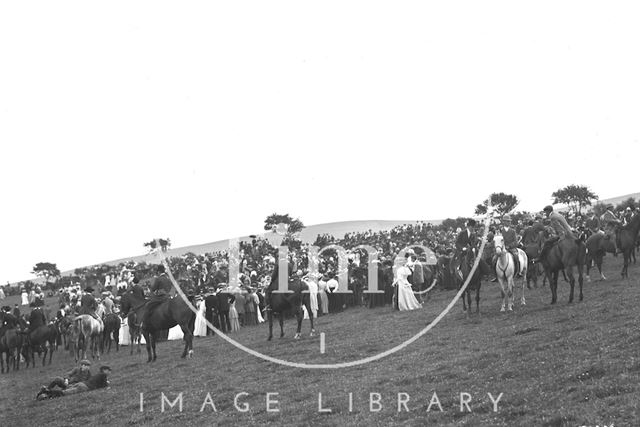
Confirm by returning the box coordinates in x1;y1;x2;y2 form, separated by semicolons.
0;1;640;283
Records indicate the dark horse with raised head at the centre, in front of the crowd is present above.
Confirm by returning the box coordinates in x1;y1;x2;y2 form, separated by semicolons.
266;264;315;341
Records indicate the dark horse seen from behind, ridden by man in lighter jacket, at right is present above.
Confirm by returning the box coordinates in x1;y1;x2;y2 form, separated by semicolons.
540;236;587;304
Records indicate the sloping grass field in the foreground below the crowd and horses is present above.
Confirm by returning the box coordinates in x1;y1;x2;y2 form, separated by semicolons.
0;257;640;426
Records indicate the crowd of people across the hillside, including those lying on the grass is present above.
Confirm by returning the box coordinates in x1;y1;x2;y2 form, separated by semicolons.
2;202;636;399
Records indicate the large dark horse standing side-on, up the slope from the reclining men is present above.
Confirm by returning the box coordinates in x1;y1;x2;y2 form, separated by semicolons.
120;291;196;362
